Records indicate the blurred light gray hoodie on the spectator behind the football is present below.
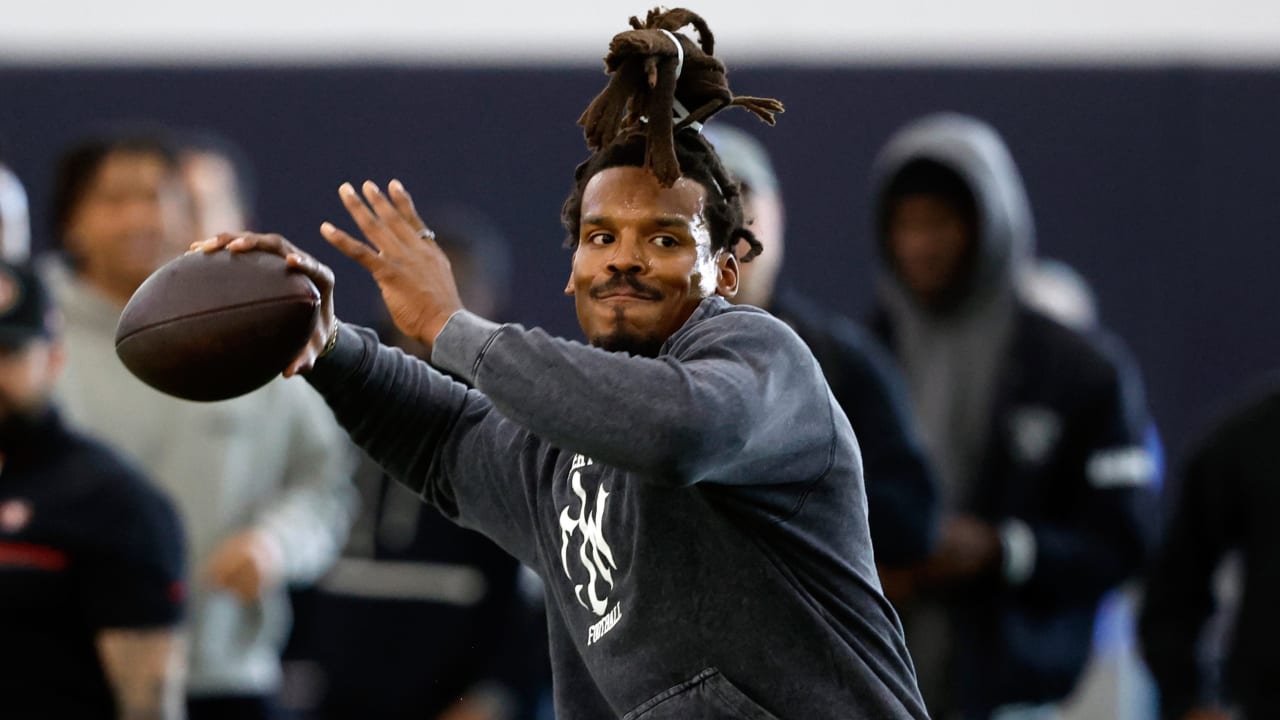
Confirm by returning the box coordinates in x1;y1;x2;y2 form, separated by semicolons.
41;261;356;696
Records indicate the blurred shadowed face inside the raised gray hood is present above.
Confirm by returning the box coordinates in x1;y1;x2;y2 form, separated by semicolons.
888;195;975;305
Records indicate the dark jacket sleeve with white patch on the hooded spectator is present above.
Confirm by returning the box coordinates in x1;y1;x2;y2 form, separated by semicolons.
1001;335;1161;602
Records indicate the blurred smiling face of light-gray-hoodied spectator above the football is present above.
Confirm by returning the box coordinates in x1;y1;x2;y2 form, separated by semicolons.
65;152;198;300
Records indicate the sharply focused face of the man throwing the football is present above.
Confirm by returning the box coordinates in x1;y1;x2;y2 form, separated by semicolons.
564;167;737;356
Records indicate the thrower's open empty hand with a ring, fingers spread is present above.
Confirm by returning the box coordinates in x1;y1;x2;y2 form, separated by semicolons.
320;179;462;348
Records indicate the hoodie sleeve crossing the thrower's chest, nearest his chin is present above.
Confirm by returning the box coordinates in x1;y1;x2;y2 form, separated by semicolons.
433;304;835;486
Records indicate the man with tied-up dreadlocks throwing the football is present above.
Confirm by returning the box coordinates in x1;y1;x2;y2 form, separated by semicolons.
197;10;927;720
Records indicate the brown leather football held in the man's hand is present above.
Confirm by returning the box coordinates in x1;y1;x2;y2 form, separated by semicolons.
115;251;320;401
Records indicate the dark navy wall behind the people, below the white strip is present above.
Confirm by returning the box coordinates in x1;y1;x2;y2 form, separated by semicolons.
0;67;1280;466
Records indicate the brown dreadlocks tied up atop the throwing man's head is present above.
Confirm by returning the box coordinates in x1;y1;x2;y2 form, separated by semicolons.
561;8;783;261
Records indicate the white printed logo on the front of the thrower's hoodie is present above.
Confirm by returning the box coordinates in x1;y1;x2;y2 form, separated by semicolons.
559;455;618;616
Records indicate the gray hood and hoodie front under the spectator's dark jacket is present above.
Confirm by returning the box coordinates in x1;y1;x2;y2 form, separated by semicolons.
872;113;1034;507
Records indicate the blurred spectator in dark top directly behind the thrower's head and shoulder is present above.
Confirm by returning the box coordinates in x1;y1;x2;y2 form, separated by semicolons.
704;126;937;566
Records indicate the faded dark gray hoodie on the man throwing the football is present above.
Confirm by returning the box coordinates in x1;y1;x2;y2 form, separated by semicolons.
307;297;925;720
